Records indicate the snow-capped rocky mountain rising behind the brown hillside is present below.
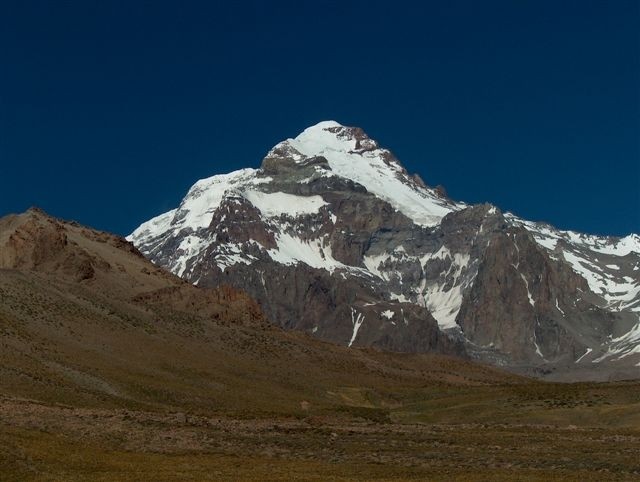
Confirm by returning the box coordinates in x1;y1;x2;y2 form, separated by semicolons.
129;121;640;376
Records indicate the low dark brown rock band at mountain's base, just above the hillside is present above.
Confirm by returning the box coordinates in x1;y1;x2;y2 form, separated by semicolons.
201;262;465;356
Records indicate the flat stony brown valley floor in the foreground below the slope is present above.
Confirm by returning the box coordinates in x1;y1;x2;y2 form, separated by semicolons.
0;398;640;481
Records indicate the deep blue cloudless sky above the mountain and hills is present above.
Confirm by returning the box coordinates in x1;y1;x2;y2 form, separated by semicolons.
0;0;640;235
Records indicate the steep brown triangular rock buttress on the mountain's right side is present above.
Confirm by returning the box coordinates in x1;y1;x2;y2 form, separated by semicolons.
458;228;632;370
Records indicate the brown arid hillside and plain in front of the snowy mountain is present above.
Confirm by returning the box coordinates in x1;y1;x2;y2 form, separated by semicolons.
0;210;640;481
